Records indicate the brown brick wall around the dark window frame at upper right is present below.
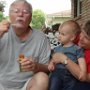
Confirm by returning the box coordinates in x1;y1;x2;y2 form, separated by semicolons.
71;0;90;24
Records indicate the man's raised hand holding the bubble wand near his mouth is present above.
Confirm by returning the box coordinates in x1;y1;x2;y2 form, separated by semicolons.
0;20;10;37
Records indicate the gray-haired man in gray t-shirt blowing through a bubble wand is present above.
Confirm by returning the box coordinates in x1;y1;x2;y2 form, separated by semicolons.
0;0;51;90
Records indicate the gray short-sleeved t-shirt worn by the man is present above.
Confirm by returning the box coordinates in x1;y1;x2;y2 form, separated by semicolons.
0;27;51;88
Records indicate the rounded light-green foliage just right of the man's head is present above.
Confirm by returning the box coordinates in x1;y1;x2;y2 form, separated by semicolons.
31;9;45;29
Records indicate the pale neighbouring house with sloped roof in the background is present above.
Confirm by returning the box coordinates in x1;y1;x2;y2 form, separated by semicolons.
46;10;71;26
